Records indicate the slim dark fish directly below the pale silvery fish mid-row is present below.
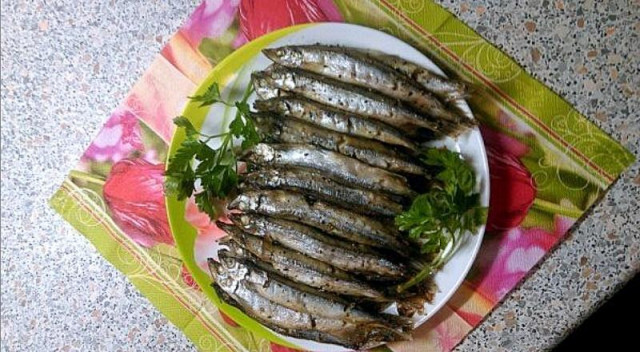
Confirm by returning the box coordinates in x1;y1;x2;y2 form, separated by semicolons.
238;168;404;216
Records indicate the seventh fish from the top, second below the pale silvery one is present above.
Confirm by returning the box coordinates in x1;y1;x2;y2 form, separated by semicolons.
228;190;410;256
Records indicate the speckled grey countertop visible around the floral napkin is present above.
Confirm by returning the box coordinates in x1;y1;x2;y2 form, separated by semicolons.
1;0;640;351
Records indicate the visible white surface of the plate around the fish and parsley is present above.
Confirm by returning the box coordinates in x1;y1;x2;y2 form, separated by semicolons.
202;23;489;352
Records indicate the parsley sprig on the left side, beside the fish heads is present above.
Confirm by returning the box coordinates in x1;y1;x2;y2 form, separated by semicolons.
165;83;260;219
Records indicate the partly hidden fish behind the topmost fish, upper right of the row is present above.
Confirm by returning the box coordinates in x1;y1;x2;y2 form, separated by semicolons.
366;51;468;102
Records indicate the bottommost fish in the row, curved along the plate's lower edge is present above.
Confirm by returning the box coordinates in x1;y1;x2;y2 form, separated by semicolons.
210;261;409;349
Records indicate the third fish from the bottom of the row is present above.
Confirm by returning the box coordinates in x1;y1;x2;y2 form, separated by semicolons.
218;228;391;302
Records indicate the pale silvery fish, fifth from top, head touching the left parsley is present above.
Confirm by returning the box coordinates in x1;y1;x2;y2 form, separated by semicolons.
240;143;415;197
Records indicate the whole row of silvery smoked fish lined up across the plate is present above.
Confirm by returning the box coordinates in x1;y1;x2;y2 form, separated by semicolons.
209;45;474;349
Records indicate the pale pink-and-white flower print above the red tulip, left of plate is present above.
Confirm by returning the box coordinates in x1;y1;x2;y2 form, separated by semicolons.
82;109;144;163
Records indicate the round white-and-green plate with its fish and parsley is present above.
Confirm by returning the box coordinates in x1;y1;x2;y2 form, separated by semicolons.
165;23;489;351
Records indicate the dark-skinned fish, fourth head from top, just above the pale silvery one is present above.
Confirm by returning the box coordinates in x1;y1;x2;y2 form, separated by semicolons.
252;113;425;175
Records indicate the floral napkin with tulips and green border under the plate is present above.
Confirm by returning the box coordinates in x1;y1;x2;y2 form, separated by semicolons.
50;0;634;351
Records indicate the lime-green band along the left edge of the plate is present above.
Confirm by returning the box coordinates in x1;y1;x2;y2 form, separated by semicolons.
165;24;313;348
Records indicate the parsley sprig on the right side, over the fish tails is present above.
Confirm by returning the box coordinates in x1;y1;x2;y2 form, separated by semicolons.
395;148;487;292
